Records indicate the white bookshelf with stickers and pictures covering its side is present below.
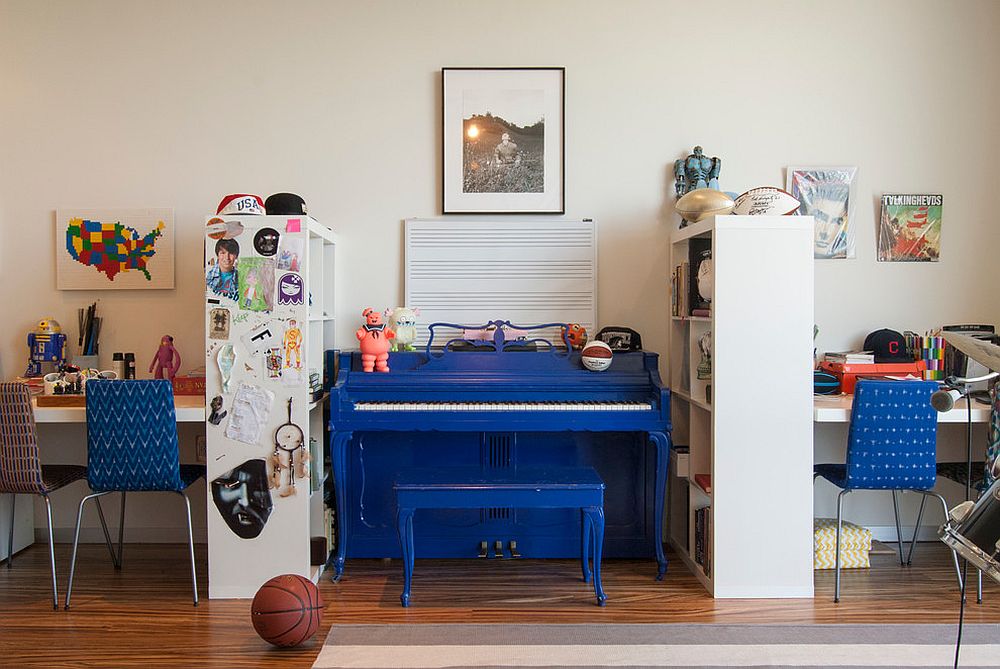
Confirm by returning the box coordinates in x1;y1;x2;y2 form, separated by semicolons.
205;216;336;598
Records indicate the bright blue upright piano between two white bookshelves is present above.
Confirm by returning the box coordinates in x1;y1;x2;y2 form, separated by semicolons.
330;322;670;579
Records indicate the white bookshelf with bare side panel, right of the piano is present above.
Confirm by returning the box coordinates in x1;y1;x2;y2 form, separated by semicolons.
668;216;814;597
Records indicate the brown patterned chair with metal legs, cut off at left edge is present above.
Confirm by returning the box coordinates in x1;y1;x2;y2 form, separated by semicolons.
0;383;111;609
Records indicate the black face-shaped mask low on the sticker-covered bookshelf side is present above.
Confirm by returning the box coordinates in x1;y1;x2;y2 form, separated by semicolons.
212;460;273;539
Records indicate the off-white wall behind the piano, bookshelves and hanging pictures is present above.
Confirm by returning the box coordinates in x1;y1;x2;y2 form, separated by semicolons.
0;0;1000;536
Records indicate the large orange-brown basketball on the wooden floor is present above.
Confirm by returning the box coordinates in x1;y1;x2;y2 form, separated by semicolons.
250;574;323;646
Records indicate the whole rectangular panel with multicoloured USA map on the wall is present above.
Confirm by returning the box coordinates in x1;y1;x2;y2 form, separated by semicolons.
56;209;174;290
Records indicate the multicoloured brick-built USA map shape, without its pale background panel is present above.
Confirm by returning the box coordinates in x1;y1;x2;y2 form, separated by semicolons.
66;218;164;281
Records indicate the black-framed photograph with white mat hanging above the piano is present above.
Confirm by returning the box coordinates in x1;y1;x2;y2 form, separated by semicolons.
441;67;565;214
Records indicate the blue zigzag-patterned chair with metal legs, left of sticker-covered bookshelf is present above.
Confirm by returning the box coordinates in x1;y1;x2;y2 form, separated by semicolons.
66;379;205;609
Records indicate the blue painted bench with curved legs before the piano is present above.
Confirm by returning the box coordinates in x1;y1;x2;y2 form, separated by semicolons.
392;467;608;606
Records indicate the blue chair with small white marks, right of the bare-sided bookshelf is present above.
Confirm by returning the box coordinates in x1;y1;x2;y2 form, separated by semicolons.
814;380;962;602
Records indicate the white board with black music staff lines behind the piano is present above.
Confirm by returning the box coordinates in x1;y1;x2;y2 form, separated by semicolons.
404;218;597;344
